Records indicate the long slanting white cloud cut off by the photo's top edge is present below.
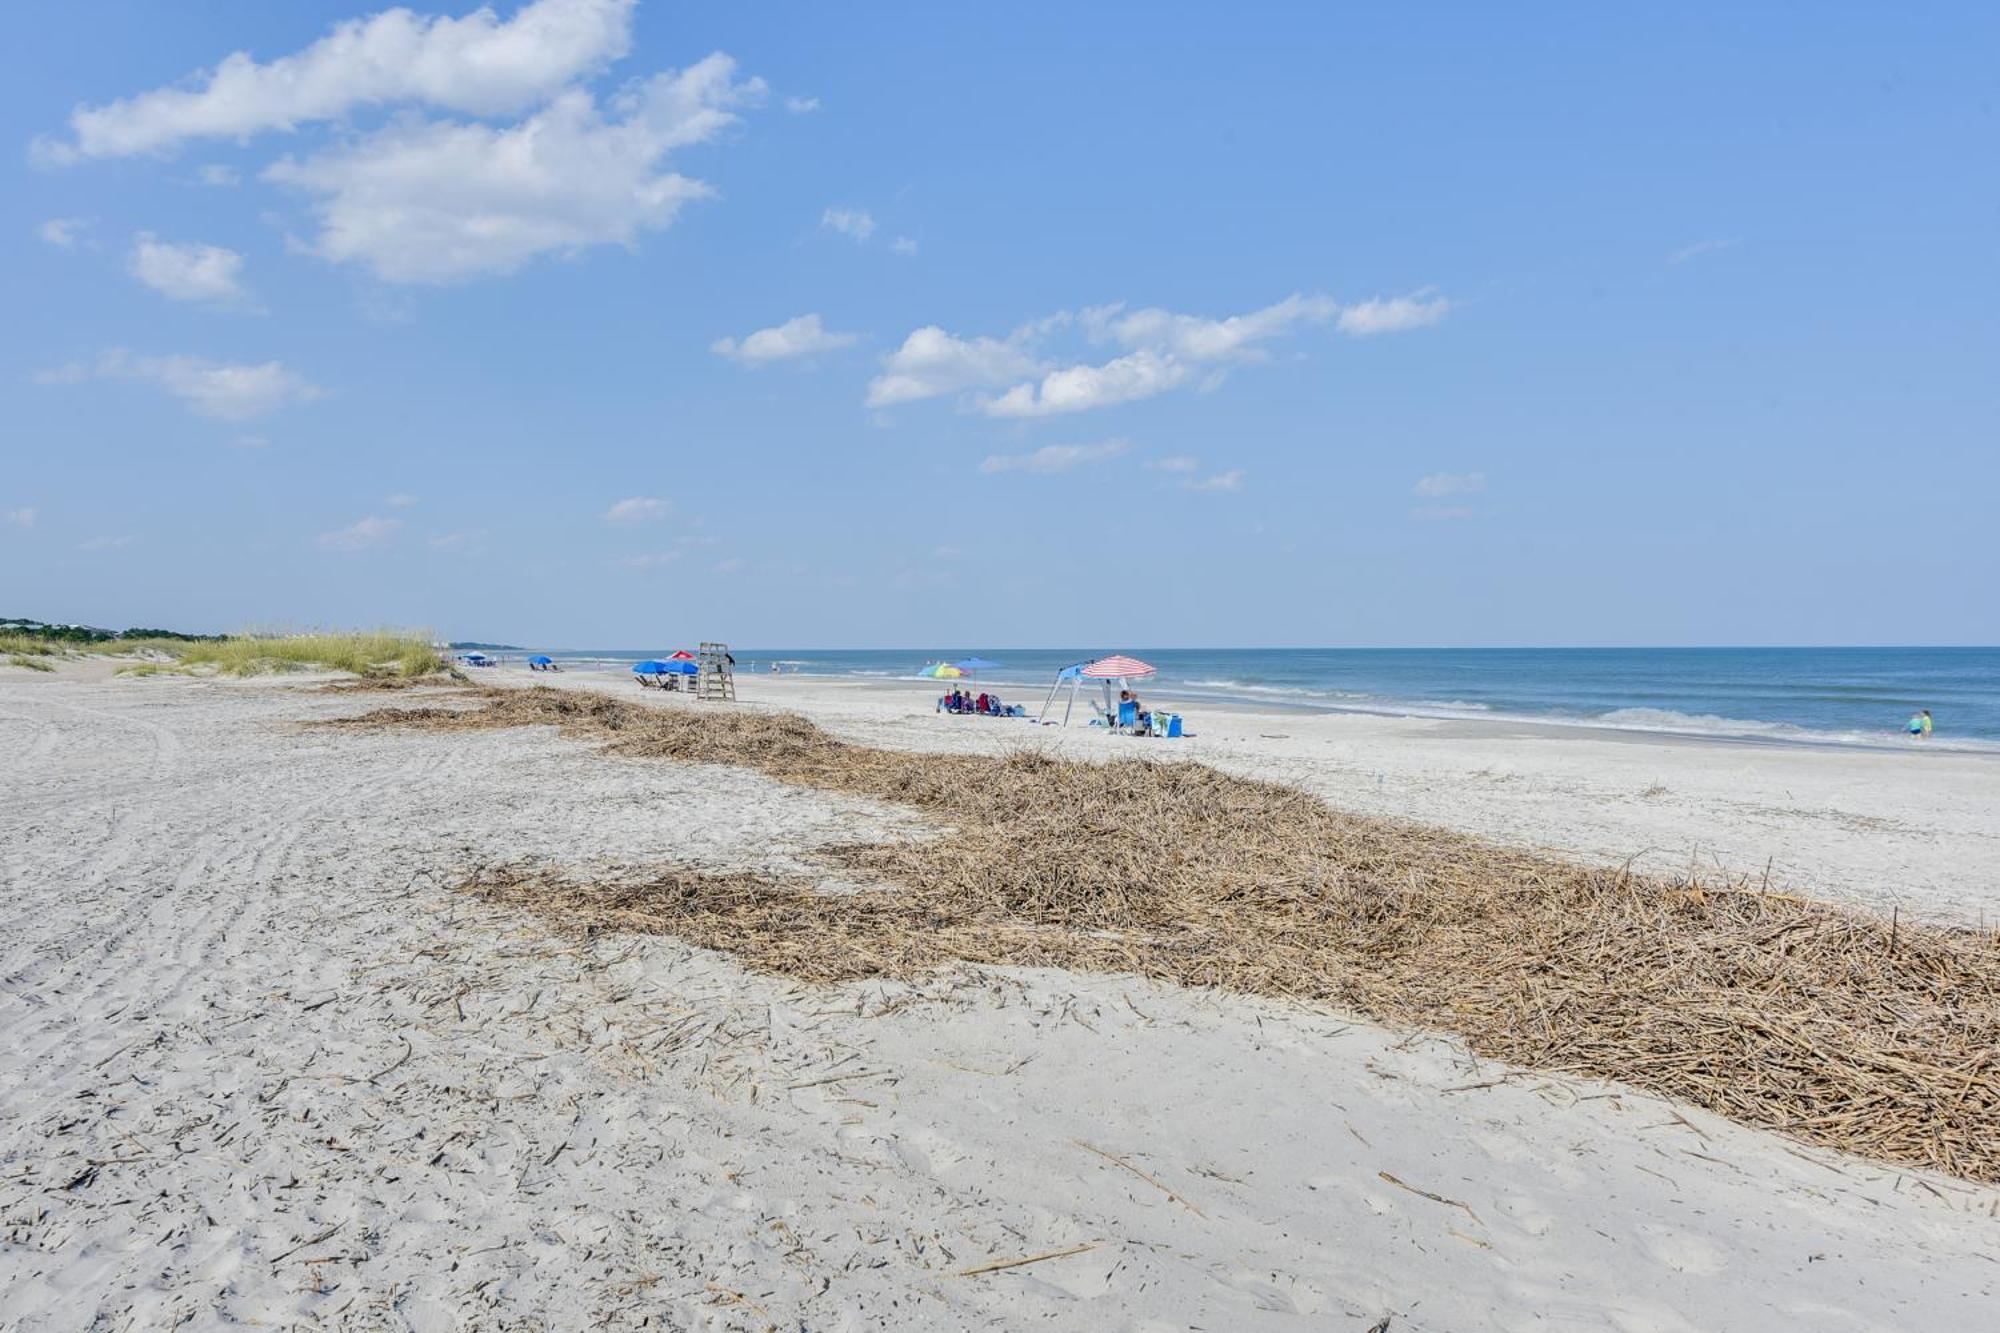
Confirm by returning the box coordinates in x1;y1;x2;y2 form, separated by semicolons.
38;0;634;162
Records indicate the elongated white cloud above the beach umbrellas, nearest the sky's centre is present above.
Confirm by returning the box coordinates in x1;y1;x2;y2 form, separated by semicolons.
868;292;1448;416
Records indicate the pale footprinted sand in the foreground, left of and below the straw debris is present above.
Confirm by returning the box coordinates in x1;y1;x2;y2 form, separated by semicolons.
0;677;2000;1333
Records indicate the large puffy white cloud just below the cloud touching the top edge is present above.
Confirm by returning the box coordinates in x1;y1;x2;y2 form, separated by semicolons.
264;57;764;282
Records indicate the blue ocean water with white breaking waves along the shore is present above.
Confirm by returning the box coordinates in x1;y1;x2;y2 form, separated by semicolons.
532;646;2000;753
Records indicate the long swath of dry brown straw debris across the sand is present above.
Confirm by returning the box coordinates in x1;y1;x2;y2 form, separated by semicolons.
324;689;2000;1181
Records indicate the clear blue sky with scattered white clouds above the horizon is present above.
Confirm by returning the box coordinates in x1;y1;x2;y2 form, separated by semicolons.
0;0;2000;648
